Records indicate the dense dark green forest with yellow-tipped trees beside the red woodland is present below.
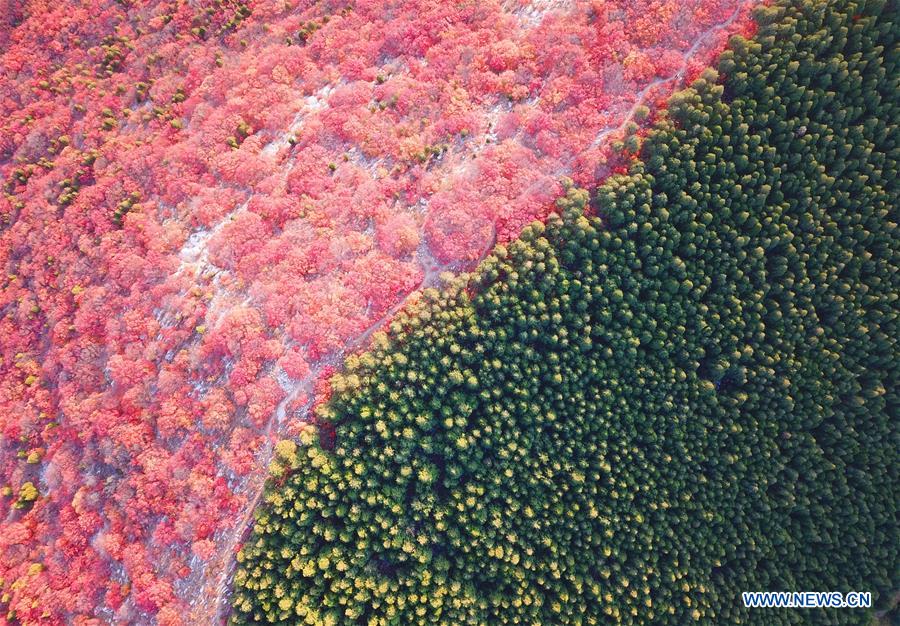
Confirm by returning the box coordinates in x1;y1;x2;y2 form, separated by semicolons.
232;0;900;626
